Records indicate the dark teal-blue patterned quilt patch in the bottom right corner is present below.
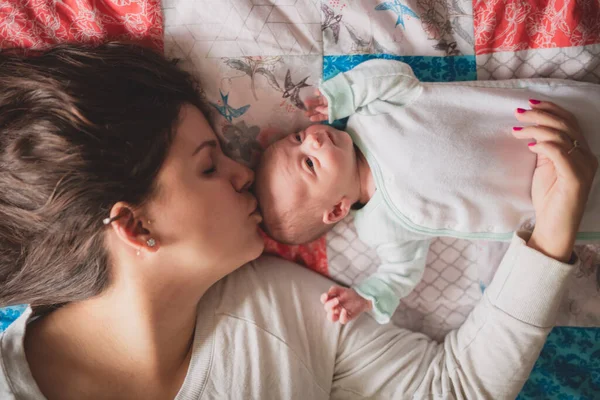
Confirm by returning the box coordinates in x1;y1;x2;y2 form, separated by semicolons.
517;327;600;400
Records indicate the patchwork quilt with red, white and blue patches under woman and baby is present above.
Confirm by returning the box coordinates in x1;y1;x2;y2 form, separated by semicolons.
0;0;600;399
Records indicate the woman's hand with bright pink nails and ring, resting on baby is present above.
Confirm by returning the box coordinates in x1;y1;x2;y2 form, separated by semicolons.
513;100;598;262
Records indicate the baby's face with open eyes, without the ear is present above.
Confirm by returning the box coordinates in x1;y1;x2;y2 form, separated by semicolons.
257;125;357;219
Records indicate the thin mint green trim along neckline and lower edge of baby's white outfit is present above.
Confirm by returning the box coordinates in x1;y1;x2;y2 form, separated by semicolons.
348;131;600;242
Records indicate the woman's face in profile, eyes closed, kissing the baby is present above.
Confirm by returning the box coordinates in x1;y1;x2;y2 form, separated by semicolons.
148;105;263;279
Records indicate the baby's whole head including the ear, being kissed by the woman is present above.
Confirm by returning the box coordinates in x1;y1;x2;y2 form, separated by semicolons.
255;125;360;244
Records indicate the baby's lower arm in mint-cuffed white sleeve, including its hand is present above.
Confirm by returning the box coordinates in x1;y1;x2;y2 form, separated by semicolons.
321;239;431;324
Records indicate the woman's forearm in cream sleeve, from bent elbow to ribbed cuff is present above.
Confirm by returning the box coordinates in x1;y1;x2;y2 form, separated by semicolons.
436;233;574;399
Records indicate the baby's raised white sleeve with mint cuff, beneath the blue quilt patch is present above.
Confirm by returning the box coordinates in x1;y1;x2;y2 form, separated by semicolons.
316;59;421;122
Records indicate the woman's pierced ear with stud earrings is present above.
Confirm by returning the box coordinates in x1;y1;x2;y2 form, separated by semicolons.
108;202;159;253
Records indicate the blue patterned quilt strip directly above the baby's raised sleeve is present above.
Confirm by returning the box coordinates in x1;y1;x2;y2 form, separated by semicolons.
323;54;477;82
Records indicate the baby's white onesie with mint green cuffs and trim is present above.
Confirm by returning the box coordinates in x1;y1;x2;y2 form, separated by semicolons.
320;60;600;322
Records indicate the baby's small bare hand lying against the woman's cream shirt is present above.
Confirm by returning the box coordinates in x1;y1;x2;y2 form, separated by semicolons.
321;286;373;325
